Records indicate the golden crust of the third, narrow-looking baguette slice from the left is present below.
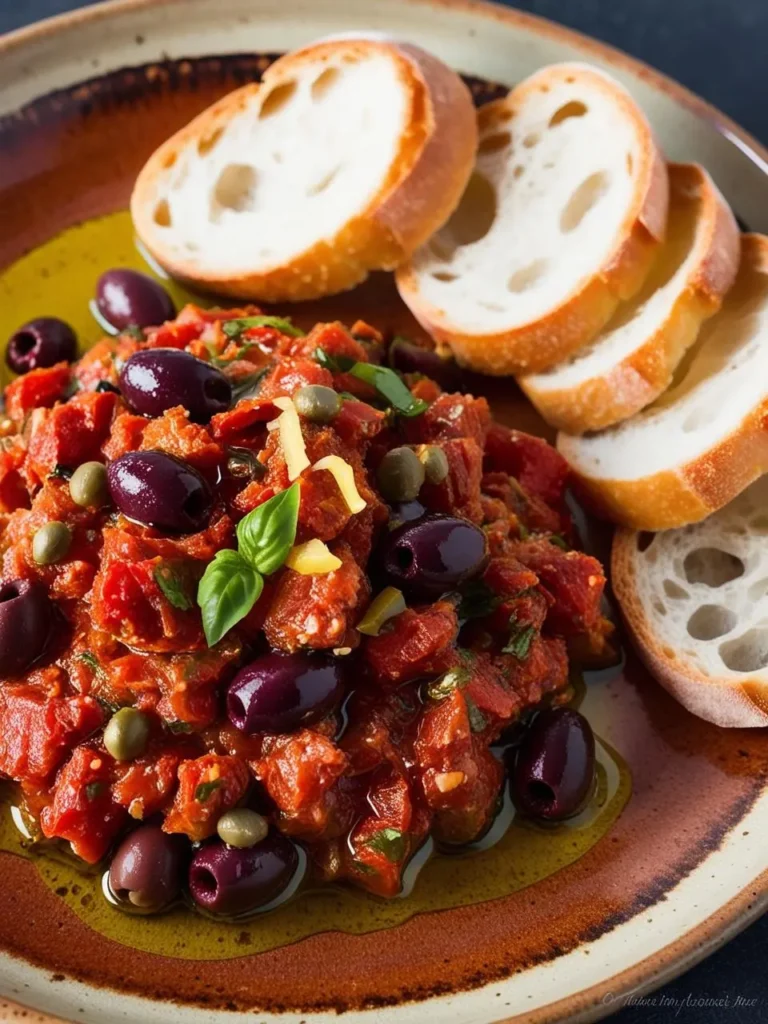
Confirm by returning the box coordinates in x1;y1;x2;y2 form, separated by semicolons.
518;164;740;434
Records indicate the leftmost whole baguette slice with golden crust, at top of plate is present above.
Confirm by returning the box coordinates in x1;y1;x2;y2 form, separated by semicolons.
131;39;477;302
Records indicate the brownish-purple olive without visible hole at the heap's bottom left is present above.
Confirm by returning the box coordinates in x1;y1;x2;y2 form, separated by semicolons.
110;825;187;911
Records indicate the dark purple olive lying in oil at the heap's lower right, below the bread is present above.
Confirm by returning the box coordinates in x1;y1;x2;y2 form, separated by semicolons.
512;708;595;821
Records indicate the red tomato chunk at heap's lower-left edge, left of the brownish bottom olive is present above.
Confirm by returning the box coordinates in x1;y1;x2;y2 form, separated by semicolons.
40;745;128;864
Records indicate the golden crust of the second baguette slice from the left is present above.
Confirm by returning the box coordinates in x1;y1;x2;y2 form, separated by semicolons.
396;63;669;376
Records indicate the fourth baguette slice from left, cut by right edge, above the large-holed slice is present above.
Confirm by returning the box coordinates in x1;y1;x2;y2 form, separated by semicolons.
557;234;768;529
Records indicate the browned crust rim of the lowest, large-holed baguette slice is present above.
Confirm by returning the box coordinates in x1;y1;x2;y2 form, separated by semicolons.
610;529;768;728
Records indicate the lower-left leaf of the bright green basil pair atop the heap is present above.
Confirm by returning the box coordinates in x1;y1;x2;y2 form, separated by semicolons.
198;549;264;647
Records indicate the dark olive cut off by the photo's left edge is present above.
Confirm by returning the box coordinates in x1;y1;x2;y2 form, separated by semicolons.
0;580;54;676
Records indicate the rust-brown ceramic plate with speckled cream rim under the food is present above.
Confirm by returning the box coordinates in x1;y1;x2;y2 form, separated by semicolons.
0;0;768;1024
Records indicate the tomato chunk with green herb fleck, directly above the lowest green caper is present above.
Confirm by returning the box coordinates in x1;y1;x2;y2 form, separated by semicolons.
163;754;249;842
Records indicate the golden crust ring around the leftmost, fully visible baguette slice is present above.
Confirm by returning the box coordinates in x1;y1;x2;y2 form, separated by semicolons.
131;39;477;302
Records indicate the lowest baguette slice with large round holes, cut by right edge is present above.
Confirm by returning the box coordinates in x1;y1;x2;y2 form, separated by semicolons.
611;477;768;727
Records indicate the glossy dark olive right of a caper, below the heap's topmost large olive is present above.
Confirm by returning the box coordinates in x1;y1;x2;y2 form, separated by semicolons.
106;451;213;534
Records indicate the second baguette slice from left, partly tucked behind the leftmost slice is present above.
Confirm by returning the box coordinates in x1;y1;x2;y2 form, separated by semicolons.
397;63;669;375
